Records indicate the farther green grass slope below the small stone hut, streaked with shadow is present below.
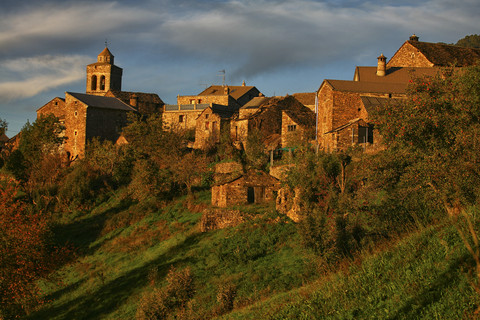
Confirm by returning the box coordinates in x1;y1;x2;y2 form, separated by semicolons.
29;192;311;319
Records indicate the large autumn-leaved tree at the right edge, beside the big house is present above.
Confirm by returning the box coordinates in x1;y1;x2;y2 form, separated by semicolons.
374;66;480;293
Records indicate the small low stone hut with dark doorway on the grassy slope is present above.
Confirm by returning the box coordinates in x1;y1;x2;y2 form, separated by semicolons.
212;170;280;207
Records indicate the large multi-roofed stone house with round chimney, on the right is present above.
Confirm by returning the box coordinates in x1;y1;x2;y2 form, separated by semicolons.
317;35;480;151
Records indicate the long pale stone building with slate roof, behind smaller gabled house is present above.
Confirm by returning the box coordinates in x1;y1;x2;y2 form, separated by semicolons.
162;82;262;130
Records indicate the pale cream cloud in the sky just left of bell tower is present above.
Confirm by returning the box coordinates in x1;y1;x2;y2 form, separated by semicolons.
0;55;91;101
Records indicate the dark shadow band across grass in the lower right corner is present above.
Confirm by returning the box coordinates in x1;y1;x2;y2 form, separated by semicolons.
390;254;474;319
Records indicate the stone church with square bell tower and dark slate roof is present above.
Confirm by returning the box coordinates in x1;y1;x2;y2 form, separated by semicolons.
37;47;164;160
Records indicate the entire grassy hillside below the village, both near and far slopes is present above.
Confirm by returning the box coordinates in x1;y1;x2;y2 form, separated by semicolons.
29;188;478;319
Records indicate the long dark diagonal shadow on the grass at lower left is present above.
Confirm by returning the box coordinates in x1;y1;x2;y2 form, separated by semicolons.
29;233;202;319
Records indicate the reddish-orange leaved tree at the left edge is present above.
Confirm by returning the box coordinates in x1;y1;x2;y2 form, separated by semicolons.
0;184;63;319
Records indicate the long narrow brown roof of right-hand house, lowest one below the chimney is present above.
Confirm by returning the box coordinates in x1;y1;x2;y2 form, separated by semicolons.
322;79;407;94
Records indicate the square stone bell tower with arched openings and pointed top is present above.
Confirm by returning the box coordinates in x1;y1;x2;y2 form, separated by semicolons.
86;45;123;96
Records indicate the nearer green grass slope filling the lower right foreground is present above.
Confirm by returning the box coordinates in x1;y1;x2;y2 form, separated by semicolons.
225;222;479;319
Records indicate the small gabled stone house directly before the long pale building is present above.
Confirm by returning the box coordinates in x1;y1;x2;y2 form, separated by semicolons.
193;104;235;149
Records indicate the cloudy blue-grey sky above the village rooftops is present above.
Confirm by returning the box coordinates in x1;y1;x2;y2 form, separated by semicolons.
0;0;480;137
